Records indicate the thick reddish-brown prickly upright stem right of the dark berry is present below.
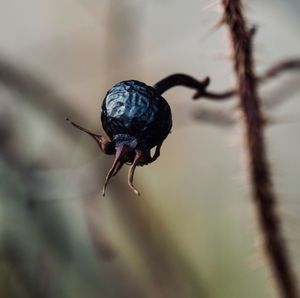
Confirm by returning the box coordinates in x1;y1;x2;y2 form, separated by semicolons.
222;0;299;298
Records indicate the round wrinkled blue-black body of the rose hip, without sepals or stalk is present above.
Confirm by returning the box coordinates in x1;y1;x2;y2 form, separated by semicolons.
101;80;172;148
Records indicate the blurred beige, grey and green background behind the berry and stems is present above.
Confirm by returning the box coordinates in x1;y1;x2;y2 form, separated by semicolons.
0;0;300;298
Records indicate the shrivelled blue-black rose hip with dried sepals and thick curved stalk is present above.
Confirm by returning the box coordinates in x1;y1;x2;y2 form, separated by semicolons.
66;74;209;196
